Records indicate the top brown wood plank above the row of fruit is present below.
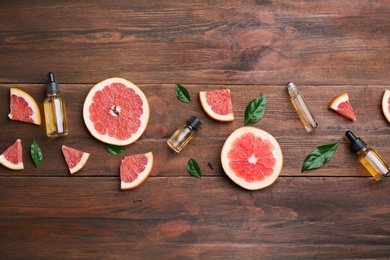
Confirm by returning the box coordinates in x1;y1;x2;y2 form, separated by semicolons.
0;0;390;85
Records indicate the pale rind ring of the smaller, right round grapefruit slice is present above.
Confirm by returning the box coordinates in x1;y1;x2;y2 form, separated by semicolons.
221;126;283;190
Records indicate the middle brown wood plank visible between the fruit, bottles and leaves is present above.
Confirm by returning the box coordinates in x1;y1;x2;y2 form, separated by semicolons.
0;84;390;177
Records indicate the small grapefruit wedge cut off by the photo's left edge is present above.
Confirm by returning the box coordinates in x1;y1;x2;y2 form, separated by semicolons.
0;139;24;170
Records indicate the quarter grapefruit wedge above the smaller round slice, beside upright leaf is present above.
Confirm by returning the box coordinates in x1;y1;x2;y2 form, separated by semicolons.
199;89;234;122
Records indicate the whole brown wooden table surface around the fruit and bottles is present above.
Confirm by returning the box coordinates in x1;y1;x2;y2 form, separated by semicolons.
0;0;390;259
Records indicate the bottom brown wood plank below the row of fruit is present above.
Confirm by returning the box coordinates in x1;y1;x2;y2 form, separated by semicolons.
0;177;390;259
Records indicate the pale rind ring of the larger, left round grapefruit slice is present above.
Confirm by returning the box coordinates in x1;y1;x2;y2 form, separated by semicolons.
83;78;150;146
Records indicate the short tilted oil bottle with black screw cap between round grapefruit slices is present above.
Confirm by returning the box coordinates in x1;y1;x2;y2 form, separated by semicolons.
167;116;202;153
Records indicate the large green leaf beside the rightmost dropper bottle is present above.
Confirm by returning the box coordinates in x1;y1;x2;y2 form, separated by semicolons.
301;142;339;173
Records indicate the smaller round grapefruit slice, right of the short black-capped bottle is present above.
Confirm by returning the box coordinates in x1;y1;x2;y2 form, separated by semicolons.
221;126;283;190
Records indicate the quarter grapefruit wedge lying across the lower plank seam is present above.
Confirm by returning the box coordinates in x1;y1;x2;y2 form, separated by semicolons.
120;152;153;190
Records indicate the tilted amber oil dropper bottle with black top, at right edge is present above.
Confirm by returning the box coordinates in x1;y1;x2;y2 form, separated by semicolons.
345;131;389;181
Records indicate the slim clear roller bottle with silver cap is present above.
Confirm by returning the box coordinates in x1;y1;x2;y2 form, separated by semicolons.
287;82;318;132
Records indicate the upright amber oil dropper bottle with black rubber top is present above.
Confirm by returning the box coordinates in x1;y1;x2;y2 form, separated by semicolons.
43;72;68;137
